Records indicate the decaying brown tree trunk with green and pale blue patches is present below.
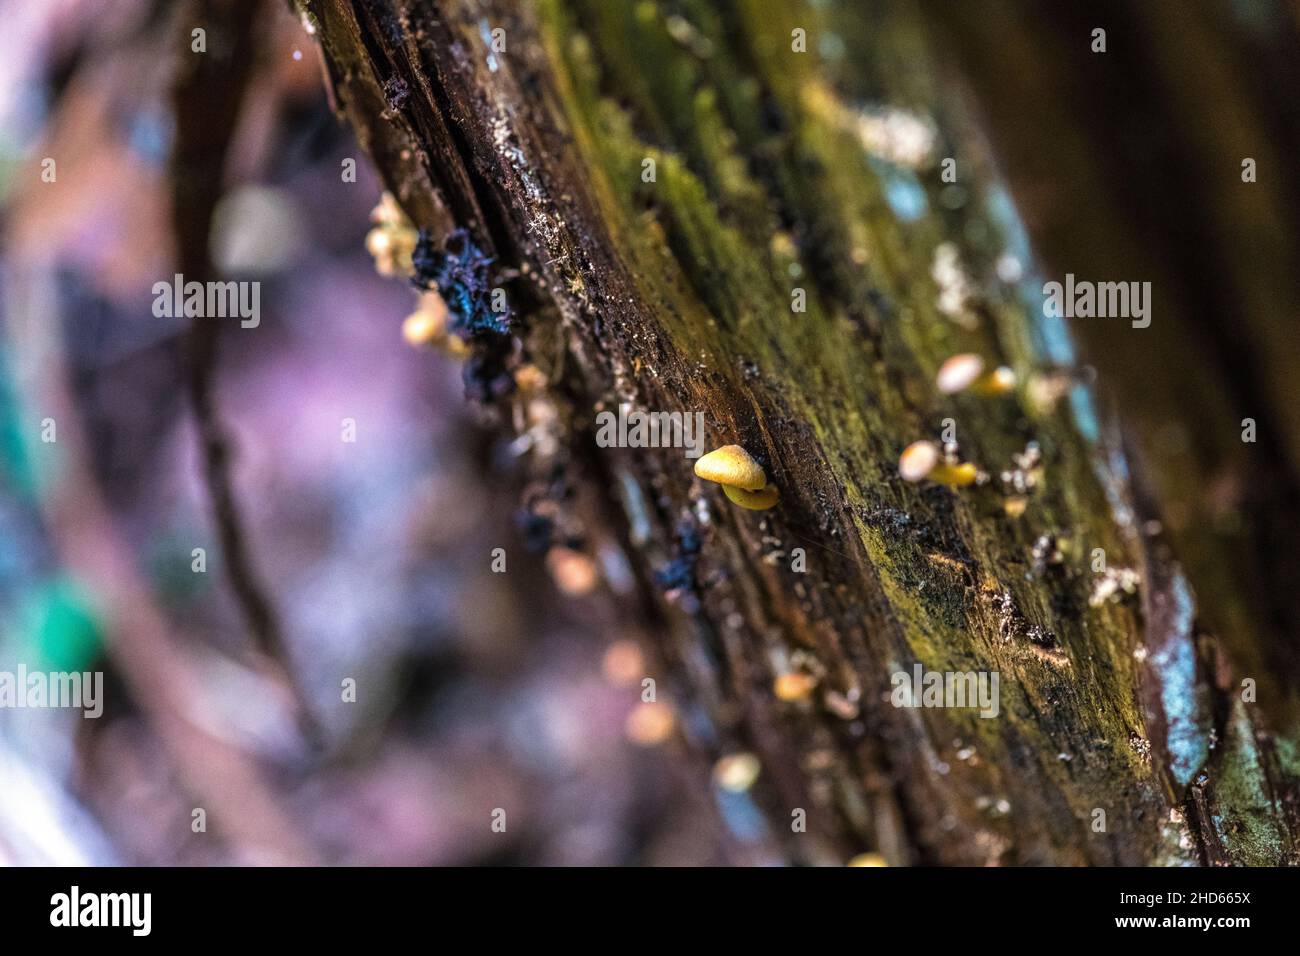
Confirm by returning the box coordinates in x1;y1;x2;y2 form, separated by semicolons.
298;0;1300;864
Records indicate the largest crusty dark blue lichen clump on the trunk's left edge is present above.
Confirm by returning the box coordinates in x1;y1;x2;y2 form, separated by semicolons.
411;229;512;339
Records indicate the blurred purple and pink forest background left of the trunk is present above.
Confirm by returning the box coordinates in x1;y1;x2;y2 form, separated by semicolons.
0;0;758;865
